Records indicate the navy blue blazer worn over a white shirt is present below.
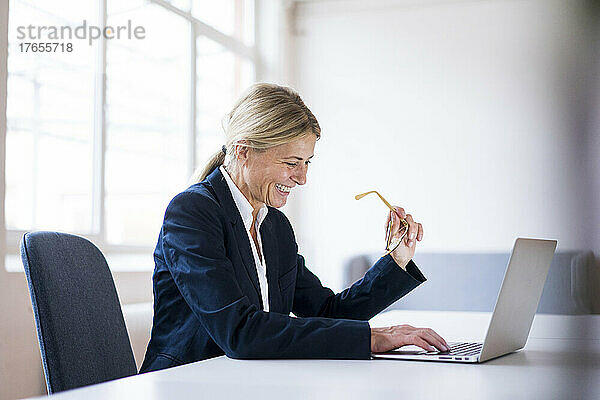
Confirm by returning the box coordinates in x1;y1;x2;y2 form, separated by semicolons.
140;168;425;372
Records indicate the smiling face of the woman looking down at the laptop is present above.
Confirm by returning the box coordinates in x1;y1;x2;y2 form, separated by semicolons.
239;134;317;209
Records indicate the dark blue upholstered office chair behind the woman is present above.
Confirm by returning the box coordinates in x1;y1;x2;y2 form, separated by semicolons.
21;232;137;394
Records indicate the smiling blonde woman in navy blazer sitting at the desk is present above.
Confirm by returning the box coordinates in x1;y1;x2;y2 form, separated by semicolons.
140;84;447;372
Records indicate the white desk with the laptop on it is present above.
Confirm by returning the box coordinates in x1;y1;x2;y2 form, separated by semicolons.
25;311;600;400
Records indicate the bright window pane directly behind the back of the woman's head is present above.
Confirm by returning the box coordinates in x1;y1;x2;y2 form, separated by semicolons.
196;36;255;169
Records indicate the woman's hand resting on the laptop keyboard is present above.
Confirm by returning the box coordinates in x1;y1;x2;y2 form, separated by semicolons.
371;325;450;353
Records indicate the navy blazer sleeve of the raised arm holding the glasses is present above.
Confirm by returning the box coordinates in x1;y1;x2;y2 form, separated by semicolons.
292;254;426;321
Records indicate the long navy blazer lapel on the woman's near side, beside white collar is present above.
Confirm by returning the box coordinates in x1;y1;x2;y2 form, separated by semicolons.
207;168;262;303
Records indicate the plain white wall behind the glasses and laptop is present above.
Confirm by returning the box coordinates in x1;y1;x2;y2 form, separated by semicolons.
292;0;590;289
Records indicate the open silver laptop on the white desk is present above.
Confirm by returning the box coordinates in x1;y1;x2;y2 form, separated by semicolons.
371;238;557;363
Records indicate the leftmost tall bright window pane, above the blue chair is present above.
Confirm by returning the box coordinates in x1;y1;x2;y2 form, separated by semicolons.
5;1;96;233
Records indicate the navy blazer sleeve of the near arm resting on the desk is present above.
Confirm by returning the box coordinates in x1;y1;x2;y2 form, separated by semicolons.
161;192;371;359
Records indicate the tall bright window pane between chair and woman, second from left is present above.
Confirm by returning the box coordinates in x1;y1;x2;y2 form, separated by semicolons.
105;0;190;246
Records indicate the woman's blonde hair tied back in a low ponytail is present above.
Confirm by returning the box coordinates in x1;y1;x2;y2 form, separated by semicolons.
192;83;321;183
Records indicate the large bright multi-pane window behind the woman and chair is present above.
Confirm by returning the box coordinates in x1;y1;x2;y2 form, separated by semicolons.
5;0;256;270
